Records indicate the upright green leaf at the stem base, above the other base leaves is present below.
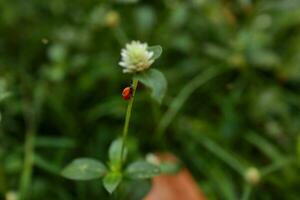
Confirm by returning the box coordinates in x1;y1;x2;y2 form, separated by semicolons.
109;138;127;168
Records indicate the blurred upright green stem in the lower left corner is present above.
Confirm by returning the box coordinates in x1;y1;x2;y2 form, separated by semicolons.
19;129;35;200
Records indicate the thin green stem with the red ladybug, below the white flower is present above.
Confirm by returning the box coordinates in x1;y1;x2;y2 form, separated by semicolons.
121;79;138;167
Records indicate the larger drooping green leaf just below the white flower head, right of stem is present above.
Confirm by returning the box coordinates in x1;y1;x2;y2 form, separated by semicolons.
135;69;167;103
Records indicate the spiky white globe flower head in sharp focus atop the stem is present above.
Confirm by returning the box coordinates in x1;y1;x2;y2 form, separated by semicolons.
119;41;154;73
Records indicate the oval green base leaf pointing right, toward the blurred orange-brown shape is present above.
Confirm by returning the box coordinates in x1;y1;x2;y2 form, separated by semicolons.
125;161;160;179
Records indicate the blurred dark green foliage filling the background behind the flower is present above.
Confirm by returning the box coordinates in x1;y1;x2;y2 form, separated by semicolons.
0;0;300;200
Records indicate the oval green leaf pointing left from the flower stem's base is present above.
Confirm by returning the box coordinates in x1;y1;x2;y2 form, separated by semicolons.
61;158;107;180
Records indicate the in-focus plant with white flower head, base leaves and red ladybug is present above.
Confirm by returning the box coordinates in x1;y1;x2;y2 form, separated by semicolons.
62;41;167;193
